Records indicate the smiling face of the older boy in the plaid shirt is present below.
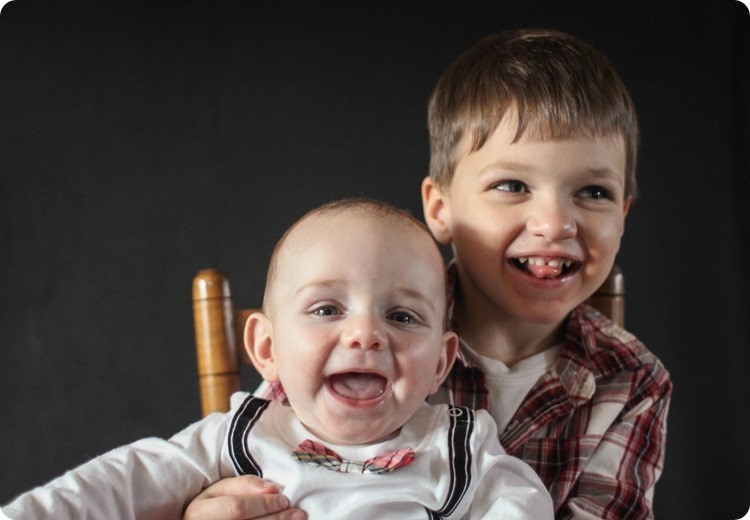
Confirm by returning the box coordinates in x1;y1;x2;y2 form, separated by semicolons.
423;111;630;325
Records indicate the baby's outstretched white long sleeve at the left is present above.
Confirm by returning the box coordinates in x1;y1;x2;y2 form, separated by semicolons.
3;414;229;520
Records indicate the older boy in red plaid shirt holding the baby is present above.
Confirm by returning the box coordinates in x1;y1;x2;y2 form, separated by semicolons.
186;30;672;519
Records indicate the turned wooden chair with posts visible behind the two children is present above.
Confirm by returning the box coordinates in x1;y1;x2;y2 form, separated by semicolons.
193;265;625;416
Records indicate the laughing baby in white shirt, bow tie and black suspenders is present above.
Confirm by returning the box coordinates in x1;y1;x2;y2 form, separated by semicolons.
2;199;552;520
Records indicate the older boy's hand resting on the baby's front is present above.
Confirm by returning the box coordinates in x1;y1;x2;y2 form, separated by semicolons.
182;475;307;520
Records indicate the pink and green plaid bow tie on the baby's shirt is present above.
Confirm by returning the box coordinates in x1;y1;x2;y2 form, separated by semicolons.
292;439;414;474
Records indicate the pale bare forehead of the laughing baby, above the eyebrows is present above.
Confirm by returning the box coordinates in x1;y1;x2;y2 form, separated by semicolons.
264;210;446;312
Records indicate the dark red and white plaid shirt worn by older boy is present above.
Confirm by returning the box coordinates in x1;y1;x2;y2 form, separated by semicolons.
264;305;672;520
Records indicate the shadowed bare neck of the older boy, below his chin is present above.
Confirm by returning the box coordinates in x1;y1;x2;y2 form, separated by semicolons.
454;299;562;367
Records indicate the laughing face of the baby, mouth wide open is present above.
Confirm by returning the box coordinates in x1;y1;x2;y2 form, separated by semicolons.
246;212;457;444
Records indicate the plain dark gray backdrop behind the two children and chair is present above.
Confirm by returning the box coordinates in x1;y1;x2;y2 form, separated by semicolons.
0;0;750;519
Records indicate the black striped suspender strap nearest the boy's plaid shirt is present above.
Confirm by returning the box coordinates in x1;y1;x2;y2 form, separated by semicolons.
427;406;475;520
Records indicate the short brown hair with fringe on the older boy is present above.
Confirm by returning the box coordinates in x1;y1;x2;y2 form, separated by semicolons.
428;29;638;197
